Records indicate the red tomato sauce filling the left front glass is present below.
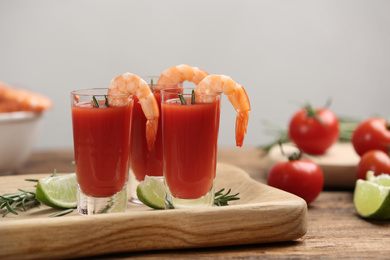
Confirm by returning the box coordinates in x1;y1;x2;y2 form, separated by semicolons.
72;102;133;197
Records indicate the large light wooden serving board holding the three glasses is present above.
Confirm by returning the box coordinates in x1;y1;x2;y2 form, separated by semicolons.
0;163;307;259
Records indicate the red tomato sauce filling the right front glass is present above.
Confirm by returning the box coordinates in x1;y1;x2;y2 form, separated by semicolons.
162;100;220;199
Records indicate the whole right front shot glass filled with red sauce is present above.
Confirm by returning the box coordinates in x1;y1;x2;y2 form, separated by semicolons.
161;88;221;208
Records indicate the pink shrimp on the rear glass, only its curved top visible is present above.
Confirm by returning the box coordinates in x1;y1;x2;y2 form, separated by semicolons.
157;64;209;85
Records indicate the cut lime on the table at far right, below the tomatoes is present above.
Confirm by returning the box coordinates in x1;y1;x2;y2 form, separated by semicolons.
353;173;390;219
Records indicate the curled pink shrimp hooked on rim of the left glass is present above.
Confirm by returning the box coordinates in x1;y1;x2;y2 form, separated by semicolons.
107;73;159;151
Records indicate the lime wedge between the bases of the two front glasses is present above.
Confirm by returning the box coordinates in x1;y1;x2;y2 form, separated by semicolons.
137;176;165;209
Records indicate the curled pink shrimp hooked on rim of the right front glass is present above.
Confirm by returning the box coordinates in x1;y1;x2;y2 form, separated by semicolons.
195;75;251;147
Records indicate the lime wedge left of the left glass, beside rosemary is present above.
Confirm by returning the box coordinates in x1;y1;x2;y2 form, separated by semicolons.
36;173;77;209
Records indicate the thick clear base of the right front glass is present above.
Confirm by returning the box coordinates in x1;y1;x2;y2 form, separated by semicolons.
165;184;214;209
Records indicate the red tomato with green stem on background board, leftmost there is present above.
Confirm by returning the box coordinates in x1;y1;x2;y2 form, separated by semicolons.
289;106;340;155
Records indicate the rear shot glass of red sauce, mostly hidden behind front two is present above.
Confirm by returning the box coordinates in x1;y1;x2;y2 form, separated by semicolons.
129;76;182;204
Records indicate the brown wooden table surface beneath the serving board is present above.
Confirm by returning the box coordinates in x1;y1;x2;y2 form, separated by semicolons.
10;148;390;259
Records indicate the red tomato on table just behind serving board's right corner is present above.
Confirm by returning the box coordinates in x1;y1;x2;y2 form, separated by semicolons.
267;150;324;205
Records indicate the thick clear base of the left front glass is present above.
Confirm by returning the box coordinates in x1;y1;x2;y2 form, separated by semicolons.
77;185;127;215
